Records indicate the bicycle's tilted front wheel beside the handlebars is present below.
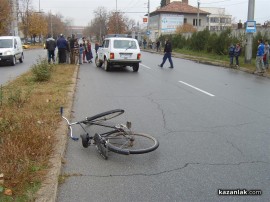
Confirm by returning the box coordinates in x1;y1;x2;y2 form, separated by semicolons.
82;109;125;123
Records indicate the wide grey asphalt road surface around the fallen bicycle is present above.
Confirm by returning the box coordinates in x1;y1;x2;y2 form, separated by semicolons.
58;53;270;202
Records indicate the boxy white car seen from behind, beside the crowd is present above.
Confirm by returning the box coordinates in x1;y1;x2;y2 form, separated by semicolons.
95;37;141;72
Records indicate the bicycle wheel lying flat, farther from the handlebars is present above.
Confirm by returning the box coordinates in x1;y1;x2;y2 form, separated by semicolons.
106;132;159;155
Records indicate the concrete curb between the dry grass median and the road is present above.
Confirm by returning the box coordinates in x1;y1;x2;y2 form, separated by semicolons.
35;66;79;202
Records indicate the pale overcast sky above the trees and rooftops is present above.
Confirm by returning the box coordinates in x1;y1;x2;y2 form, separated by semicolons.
32;0;270;26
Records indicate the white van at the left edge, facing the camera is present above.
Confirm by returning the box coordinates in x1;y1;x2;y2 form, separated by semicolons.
0;36;24;66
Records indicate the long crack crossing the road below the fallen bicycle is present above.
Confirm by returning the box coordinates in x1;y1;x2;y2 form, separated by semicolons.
63;161;270;178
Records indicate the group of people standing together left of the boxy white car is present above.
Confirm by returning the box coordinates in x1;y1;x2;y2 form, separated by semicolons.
45;34;93;64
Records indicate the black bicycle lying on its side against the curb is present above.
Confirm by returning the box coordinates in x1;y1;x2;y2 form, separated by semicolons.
61;107;159;159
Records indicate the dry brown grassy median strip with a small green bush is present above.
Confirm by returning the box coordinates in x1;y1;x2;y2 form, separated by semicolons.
0;58;75;202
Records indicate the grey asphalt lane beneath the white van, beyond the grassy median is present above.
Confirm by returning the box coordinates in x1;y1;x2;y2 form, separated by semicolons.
0;49;47;85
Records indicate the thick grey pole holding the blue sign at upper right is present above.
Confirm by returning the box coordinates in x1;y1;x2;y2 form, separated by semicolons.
245;0;255;64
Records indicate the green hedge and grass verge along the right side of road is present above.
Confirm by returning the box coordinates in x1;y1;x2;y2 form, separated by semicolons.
159;29;269;73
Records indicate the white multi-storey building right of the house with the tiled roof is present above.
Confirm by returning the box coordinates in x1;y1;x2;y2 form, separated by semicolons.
200;7;232;31
